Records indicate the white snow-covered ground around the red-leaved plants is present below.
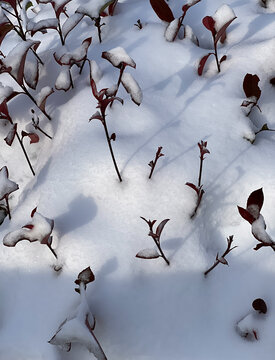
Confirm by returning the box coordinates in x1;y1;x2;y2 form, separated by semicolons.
0;0;275;360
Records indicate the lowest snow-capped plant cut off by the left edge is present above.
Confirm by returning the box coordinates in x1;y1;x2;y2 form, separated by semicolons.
0;166;19;219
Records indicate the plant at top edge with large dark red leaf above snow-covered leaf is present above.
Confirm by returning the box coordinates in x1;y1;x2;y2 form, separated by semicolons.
150;0;201;43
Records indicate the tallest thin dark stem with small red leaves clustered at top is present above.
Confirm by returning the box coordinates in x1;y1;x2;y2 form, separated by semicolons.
89;63;123;182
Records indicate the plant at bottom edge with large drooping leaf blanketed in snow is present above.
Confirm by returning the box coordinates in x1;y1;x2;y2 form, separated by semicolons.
49;267;107;360
